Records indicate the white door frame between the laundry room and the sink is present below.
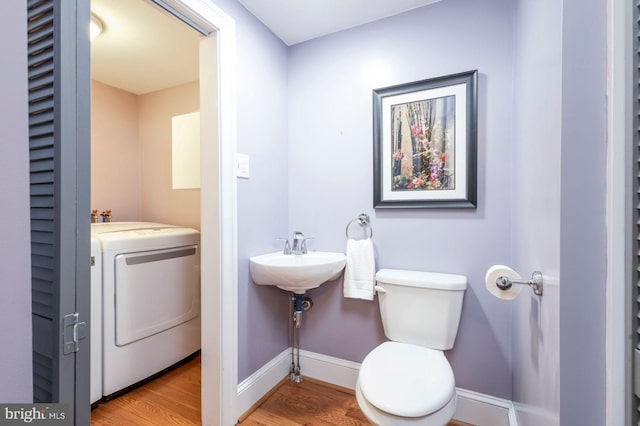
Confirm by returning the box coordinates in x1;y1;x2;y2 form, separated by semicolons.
164;0;239;426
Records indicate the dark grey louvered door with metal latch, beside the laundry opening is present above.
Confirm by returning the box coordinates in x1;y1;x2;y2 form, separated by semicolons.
27;0;90;424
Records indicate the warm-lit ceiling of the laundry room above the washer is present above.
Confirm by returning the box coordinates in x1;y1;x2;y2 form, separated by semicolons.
91;0;202;95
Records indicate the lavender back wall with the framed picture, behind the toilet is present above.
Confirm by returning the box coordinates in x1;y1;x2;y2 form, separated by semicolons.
288;0;514;399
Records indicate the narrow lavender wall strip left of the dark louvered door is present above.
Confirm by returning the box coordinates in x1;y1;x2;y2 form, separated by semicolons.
0;2;33;403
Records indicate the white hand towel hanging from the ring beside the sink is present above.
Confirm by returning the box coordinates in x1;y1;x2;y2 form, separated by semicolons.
343;238;376;300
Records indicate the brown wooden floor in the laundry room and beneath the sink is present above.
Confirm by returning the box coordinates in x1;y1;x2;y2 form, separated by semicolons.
91;356;466;426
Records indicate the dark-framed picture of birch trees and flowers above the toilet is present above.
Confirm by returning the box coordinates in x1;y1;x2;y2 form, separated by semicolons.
373;71;478;208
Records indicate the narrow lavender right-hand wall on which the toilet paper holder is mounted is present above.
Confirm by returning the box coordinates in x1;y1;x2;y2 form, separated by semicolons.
511;0;562;426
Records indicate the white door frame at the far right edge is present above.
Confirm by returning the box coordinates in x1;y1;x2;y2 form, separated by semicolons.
606;0;632;426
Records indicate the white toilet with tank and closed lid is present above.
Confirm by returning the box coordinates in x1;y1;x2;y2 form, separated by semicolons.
356;269;467;426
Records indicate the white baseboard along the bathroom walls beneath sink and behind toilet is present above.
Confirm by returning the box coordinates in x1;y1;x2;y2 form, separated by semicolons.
238;349;517;426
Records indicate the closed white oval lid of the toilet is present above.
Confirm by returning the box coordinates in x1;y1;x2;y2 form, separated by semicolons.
358;342;455;417
